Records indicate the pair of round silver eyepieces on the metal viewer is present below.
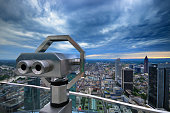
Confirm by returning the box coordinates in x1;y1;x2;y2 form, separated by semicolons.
17;60;53;75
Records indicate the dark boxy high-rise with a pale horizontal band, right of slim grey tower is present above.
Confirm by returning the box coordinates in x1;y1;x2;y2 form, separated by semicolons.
122;69;133;91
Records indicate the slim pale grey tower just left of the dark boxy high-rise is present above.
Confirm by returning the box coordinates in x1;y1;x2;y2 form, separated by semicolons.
115;58;122;82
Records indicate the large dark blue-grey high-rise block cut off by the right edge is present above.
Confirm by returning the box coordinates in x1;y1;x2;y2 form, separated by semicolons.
148;64;170;110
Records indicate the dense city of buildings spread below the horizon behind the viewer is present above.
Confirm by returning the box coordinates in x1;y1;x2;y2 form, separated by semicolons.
0;54;170;113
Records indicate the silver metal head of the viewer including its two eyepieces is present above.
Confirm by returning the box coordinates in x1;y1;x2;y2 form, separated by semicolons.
16;53;80;78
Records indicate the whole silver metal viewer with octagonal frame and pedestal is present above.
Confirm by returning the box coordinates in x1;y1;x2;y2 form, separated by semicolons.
16;35;84;113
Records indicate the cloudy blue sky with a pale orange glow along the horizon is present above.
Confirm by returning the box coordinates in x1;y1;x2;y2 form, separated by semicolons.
0;0;170;59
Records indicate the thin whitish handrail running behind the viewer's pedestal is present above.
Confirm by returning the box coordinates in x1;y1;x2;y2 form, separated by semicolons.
0;82;169;113
